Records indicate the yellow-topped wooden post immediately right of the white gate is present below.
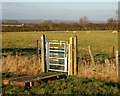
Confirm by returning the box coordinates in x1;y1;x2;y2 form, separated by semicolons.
70;37;74;75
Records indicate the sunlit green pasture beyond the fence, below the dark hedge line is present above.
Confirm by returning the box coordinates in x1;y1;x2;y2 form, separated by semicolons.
2;31;118;54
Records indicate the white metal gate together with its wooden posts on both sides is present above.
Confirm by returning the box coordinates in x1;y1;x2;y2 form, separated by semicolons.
37;35;77;75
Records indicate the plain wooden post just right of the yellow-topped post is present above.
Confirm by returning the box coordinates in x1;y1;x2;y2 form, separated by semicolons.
74;36;77;75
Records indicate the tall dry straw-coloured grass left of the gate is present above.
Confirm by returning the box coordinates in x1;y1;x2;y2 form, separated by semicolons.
2;55;41;75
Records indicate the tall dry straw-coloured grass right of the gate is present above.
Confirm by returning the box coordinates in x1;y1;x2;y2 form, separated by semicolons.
78;60;118;82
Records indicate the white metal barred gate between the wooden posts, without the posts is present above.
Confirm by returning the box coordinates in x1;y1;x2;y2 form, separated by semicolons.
46;40;69;72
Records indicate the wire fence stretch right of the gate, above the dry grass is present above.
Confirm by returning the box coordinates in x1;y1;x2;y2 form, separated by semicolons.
78;46;116;64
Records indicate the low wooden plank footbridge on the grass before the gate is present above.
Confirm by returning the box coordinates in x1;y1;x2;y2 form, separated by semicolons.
3;74;66;87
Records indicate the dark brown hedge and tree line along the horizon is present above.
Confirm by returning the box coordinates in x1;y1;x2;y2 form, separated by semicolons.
2;17;118;32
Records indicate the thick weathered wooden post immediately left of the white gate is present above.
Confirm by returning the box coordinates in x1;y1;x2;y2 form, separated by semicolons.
41;35;46;72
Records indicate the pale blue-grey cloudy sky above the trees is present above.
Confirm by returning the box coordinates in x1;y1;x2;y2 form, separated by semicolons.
2;0;118;21
